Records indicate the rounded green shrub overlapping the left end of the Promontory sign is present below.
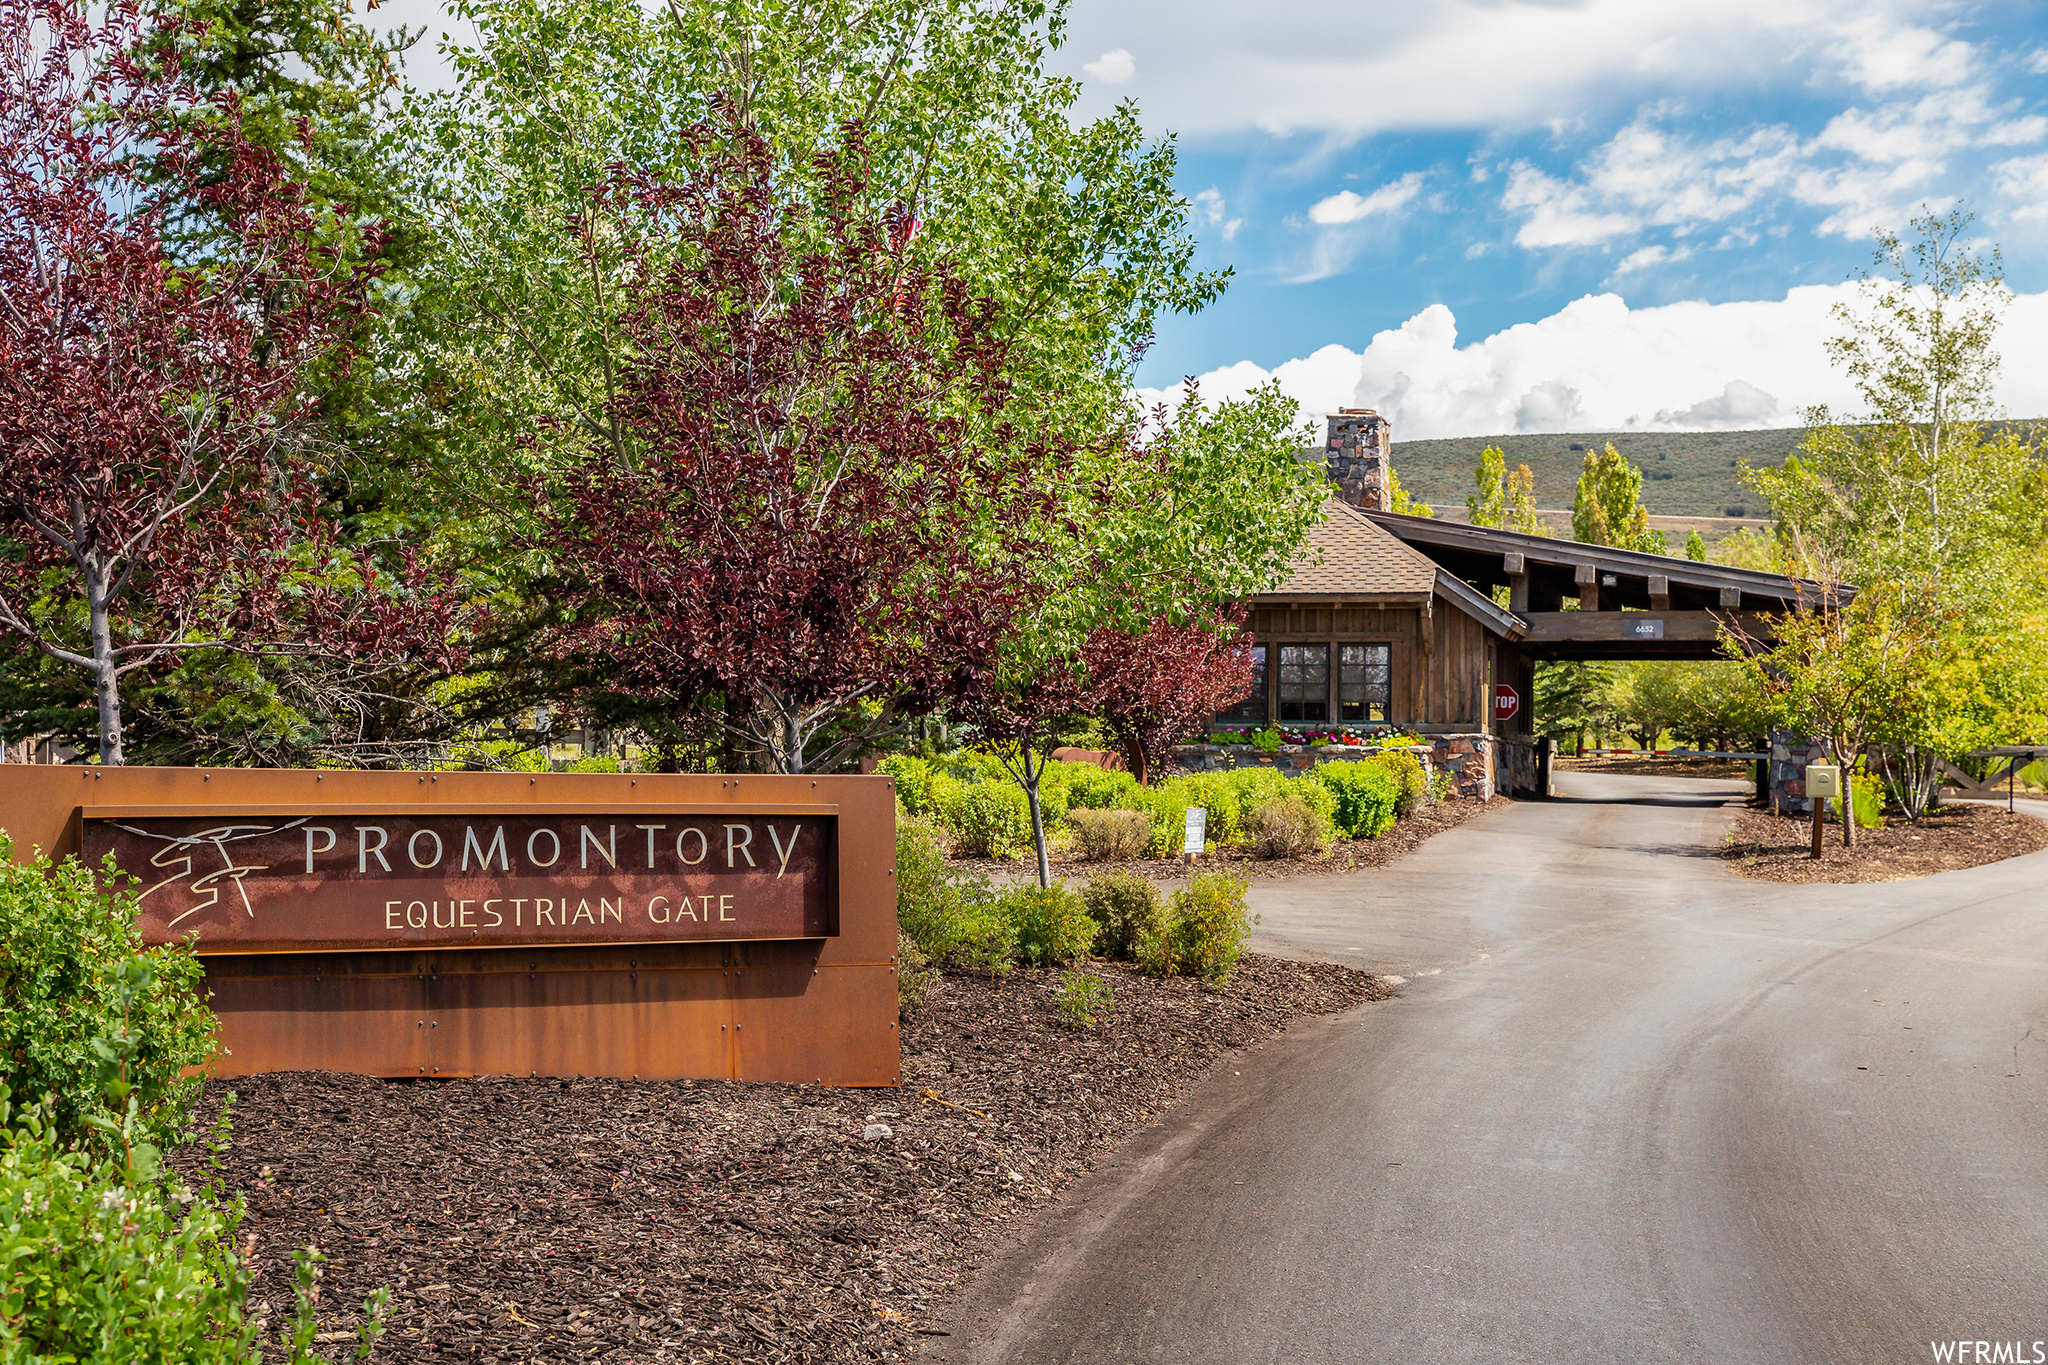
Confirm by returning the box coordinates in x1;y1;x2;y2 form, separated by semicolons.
0;833;213;1150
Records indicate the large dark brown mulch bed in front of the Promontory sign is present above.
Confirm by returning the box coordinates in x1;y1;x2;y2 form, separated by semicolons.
192;956;1393;1365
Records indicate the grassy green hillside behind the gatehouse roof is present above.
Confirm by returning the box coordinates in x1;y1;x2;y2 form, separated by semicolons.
1395;426;1804;518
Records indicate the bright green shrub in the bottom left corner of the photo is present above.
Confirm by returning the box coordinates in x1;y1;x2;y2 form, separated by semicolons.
0;1099;391;1365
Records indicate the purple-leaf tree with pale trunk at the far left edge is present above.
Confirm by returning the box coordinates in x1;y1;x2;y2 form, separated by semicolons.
0;0;453;763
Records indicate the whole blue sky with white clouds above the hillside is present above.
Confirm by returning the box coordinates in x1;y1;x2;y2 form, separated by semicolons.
1059;0;2048;438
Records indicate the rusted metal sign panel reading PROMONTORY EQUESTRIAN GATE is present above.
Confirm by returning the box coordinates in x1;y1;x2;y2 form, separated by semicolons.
80;806;840;954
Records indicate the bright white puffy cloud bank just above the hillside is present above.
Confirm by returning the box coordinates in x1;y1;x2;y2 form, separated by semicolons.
1145;284;2048;444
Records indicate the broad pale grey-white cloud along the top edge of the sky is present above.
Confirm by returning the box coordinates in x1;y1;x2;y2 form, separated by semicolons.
1069;0;1976;139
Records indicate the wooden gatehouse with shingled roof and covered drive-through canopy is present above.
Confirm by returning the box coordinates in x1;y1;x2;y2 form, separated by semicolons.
1217;497;1823;792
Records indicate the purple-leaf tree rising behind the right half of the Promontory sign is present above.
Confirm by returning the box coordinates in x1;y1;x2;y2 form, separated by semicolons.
541;121;1038;772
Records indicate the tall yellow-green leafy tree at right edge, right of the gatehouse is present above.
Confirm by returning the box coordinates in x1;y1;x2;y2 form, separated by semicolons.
1745;211;2048;814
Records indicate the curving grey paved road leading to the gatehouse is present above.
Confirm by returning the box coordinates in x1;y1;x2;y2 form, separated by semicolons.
934;774;2048;1365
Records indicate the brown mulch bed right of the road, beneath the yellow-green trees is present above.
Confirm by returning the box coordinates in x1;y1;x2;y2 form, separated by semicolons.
1720;806;2048;882
